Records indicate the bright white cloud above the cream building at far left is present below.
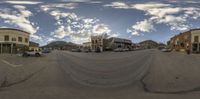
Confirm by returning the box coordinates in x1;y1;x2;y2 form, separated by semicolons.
0;5;39;34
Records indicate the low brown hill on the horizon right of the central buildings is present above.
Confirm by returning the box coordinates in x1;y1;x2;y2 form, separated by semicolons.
139;40;159;49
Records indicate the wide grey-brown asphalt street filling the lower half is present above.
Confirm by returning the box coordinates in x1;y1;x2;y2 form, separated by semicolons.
0;50;200;99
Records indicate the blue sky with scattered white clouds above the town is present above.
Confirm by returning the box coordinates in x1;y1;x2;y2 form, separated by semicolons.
0;0;200;45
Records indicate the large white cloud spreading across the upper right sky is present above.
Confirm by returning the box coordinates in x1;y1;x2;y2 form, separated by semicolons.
104;2;200;35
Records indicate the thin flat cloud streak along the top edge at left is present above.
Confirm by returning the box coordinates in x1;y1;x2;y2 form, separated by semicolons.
4;1;42;5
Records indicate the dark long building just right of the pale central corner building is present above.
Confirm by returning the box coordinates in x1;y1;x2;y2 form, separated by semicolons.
107;37;132;50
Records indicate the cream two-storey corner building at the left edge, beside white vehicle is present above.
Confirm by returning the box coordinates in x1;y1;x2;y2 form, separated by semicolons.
0;28;30;53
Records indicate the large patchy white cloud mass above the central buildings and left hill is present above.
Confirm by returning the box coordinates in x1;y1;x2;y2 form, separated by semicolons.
41;6;116;44
